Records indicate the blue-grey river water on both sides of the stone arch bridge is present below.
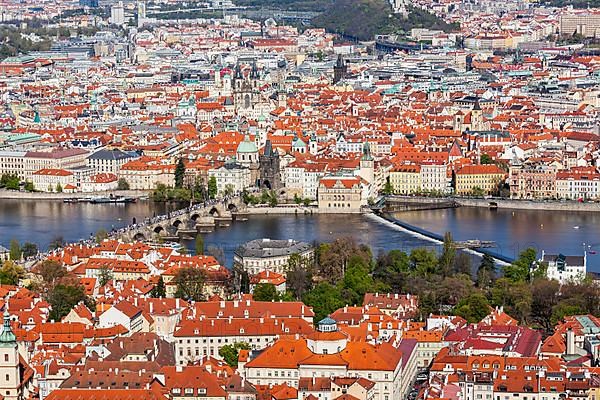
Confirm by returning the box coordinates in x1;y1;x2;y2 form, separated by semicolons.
0;200;600;271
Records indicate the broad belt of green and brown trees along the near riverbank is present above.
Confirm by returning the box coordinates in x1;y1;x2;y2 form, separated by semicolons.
224;233;600;333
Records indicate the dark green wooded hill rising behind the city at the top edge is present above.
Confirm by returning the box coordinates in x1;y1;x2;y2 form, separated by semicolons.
312;0;458;40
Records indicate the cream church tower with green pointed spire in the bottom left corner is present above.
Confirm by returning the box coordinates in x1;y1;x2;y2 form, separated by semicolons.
0;312;22;400
